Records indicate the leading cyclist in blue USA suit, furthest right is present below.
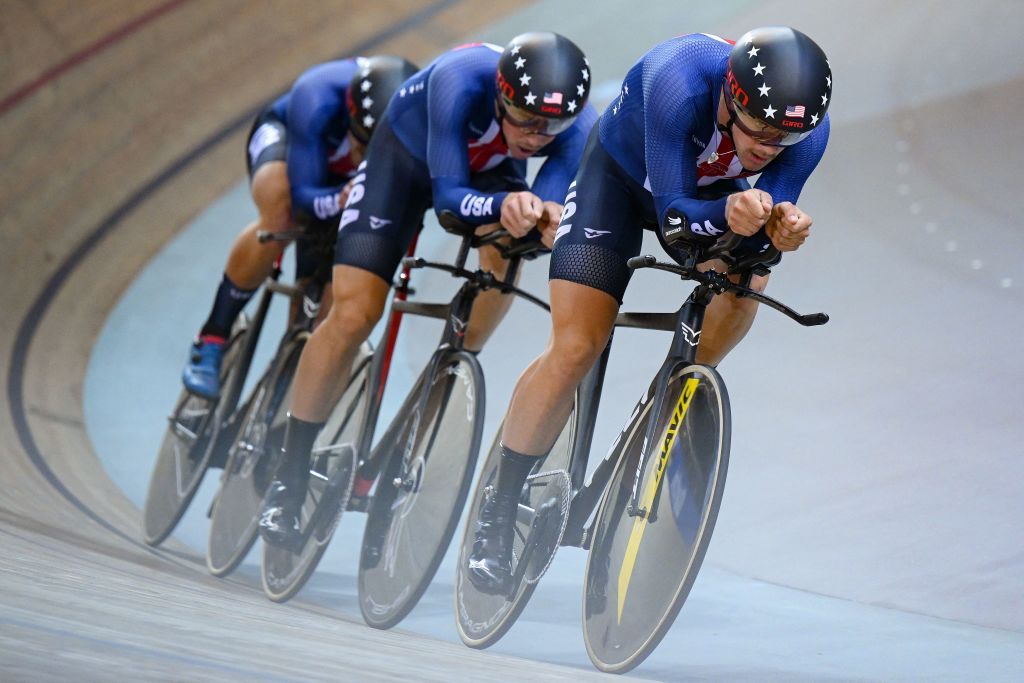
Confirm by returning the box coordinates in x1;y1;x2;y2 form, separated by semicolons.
466;27;831;594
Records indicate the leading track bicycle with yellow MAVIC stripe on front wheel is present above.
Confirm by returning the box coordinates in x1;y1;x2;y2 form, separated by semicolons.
455;240;828;673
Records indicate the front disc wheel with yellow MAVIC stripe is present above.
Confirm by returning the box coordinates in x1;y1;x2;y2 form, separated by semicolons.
583;366;730;673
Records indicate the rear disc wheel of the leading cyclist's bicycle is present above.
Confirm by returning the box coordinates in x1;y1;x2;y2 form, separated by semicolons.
455;401;575;648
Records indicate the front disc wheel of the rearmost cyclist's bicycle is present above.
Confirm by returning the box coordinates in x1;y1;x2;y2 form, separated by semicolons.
206;334;308;577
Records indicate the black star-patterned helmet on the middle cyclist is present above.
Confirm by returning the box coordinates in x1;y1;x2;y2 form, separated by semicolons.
497;31;590;135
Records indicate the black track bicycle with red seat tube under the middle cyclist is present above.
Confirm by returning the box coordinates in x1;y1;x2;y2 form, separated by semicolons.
263;212;546;629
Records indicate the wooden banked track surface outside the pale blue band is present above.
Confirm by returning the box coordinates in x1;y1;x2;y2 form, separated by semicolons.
0;0;622;680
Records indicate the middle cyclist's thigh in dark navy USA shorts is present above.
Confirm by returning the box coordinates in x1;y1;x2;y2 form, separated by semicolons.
334;120;430;284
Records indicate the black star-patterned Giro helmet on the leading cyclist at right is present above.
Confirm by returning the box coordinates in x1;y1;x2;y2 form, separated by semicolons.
725;27;831;145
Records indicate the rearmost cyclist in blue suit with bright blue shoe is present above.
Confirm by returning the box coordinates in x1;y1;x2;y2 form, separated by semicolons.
182;55;417;398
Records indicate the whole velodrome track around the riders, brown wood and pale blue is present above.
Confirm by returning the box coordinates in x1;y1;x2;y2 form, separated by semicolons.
0;0;1024;680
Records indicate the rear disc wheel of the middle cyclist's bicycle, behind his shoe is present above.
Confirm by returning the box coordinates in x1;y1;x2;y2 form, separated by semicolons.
260;344;371;602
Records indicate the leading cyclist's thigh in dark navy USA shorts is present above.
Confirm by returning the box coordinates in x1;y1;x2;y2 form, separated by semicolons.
549;132;645;303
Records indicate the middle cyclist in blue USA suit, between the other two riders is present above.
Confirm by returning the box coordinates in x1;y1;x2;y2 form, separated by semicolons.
260;33;597;544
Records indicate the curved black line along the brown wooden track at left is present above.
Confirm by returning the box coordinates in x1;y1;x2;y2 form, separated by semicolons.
7;0;460;556
